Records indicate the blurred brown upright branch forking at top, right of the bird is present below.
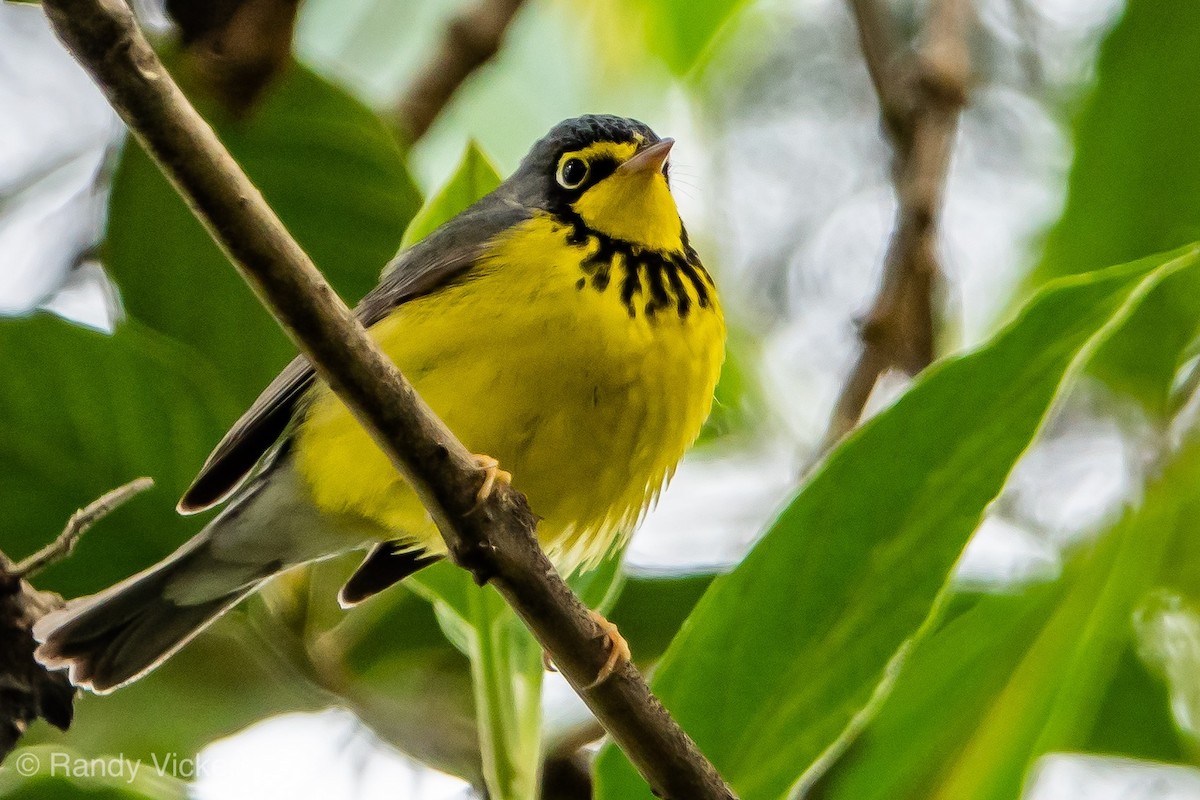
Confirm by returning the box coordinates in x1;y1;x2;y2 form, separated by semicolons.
821;0;971;452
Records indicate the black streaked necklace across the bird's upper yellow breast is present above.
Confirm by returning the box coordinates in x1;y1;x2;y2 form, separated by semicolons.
562;215;713;320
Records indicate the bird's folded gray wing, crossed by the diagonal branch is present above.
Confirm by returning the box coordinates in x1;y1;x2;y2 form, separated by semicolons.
179;194;529;513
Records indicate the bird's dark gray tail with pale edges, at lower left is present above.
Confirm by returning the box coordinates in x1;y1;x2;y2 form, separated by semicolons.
34;515;286;694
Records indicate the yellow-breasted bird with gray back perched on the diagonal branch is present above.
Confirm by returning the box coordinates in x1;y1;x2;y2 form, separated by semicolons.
36;116;725;692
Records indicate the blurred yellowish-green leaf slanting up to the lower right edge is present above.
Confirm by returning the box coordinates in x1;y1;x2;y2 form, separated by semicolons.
920;445;1200;800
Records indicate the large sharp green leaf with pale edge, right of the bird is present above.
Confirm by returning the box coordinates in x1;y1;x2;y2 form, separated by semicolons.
598;248;1200;800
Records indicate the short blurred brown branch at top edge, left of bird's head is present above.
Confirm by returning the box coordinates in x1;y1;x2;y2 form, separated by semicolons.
392;0;523;143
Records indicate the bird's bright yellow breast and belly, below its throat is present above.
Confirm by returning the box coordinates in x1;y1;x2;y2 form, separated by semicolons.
294;215;725;571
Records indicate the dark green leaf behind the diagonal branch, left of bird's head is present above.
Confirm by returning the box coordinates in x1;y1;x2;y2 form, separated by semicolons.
103;65;420;407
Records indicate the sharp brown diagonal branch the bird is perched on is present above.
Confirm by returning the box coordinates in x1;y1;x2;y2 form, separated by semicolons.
42;0;733;800
